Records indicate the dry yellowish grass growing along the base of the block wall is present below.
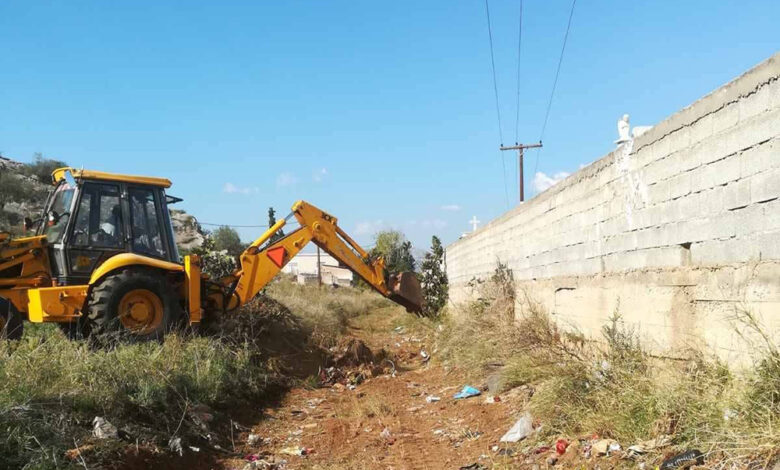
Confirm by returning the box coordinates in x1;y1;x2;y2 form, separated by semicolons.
439;264;780;468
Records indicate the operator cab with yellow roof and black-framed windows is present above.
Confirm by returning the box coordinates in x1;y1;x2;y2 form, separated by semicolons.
37;168;179;285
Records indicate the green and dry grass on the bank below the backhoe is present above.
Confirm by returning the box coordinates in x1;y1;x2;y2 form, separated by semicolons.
0;282;387;469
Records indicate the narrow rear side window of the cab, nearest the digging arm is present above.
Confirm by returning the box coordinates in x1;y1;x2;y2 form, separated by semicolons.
129;188;165;258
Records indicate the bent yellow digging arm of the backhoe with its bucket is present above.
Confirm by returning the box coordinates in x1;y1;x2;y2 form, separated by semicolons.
207;201;423;313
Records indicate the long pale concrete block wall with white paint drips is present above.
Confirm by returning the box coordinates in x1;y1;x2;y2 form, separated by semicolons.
446;54;780;359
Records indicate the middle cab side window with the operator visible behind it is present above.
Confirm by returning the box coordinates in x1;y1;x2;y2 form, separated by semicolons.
72;183;124;248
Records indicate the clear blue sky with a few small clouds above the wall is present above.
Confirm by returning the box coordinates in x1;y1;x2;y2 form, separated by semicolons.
0;0;780;247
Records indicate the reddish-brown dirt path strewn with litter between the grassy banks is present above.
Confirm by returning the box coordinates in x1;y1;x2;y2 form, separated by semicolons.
216;311;525;469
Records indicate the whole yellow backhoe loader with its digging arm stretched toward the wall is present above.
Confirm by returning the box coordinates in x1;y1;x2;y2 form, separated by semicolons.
0;168;422;340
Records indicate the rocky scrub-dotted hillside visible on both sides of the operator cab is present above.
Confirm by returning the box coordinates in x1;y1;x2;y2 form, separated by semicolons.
0;155;205;252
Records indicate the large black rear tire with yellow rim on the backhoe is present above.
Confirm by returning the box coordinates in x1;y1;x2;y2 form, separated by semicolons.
87;268;182;344
